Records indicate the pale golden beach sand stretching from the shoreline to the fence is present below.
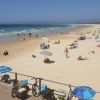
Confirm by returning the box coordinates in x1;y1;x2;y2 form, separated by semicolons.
0;24;100;100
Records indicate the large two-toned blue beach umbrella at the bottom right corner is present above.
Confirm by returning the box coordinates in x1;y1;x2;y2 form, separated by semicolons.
72;86;96;100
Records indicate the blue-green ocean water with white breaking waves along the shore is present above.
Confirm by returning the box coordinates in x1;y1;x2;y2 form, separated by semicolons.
0;24;80;41
